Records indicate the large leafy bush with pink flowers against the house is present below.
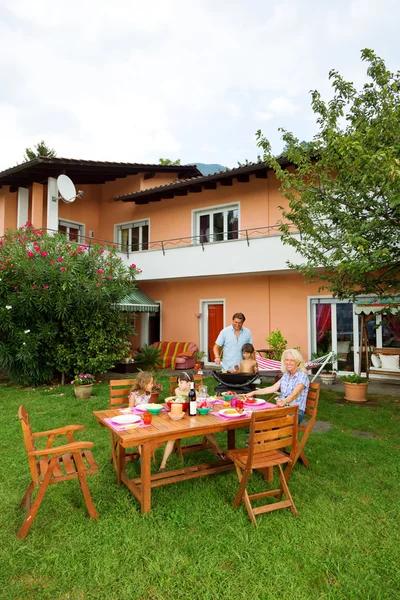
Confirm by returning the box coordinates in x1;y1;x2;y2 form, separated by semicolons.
0;224;138;385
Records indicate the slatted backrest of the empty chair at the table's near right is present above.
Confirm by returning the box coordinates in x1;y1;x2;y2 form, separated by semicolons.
247;405;298;468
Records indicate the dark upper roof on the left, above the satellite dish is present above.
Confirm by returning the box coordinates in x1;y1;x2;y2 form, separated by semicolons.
0;156;201;192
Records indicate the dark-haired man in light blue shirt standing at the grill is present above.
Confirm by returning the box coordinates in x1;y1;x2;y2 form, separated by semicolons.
213;313;253;371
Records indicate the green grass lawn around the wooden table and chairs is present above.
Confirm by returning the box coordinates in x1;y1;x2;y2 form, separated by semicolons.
0;378;400;600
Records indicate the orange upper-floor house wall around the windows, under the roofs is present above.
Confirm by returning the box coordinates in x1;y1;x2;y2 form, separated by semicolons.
0;173;290;242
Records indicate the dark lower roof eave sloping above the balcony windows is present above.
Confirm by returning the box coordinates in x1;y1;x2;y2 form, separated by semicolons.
114;157;291;204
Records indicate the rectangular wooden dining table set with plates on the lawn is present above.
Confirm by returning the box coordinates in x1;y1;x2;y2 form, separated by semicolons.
93;406;268;513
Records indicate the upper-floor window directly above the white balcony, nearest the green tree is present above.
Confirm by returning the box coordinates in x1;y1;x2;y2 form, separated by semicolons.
195;204;239;244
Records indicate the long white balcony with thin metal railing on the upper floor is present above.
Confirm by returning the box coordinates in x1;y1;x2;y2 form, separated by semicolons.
115;227;301;281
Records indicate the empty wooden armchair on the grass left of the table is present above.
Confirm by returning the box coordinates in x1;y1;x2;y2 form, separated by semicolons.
17;406;99;538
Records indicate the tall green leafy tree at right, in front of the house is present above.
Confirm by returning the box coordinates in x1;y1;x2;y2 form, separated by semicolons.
257;49;400;299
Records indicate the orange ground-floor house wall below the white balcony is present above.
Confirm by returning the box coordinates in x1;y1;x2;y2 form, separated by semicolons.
139;273;319;358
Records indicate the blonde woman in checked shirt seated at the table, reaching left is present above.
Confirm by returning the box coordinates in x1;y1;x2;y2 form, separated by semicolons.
246;348;310;423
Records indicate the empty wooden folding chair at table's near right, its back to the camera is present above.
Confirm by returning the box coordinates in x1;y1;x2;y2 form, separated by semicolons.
227;405;298;526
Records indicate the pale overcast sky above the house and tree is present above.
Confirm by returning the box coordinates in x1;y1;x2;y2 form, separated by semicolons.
0;0;400;170
